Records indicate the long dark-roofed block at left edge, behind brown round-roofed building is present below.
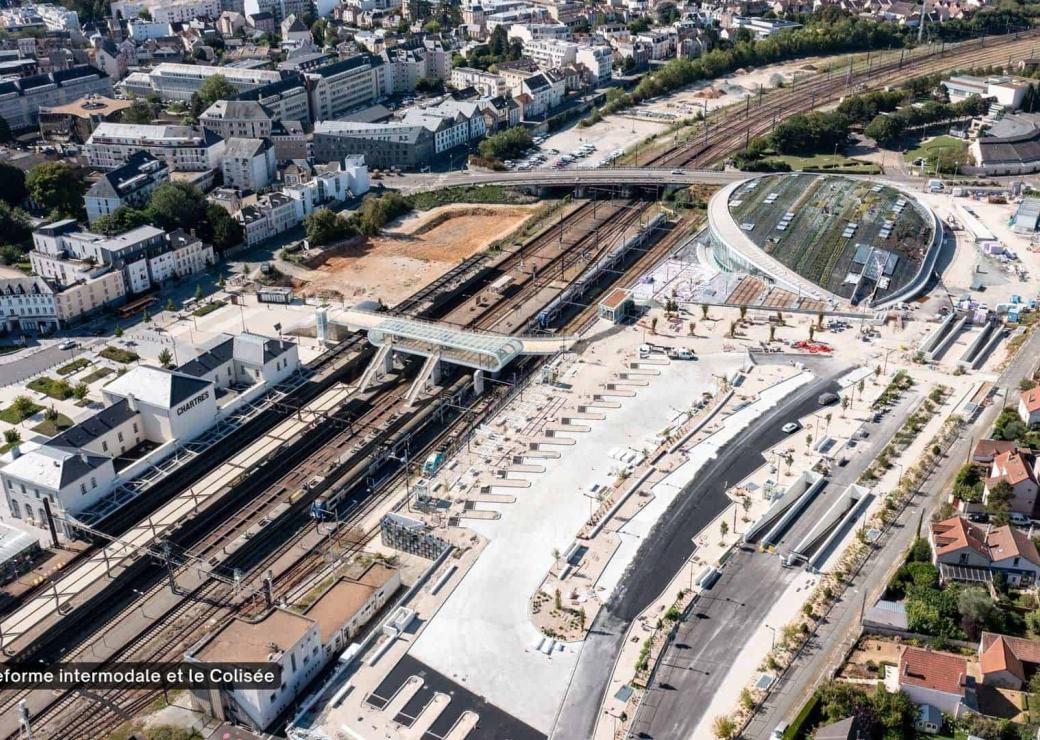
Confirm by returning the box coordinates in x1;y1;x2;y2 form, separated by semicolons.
0;64;112;131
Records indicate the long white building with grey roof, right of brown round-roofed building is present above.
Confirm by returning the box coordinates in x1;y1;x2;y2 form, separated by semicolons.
84;123;225;171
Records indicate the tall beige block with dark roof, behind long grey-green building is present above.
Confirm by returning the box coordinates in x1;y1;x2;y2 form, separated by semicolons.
307;54;388;121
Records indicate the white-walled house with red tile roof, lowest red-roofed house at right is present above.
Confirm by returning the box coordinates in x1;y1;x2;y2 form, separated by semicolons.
886;648;978;718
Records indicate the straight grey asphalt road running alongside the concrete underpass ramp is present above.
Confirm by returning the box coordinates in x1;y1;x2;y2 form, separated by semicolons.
632;386;919;740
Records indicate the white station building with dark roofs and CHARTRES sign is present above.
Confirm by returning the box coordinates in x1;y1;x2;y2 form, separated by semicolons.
0;334;300;540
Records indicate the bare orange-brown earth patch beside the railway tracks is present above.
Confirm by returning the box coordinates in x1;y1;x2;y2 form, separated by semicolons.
295;205;538;305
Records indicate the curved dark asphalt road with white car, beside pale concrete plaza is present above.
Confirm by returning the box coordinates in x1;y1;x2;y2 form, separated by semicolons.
551;370;838;740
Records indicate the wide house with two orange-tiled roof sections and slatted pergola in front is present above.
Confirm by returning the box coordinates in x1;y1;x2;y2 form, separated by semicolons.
930;517;1040;586
